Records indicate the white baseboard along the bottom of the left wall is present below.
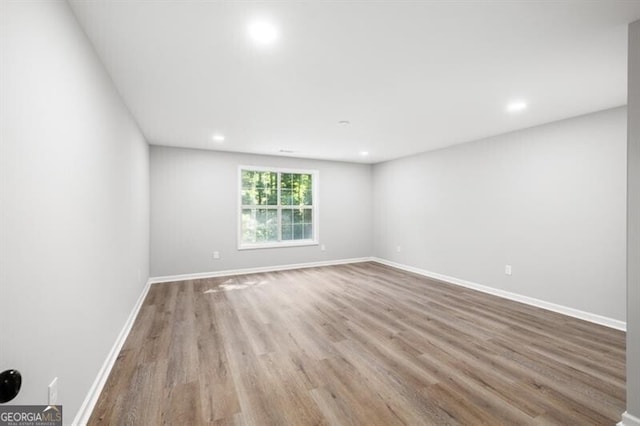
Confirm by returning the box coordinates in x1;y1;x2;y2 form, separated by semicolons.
71;281;151;426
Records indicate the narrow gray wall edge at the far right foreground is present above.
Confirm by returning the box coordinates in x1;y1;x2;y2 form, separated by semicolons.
627;17;640;426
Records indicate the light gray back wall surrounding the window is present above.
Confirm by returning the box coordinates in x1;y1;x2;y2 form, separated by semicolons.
150;146;373;277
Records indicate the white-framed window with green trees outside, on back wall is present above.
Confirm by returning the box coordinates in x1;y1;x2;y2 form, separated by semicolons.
239;166;318;249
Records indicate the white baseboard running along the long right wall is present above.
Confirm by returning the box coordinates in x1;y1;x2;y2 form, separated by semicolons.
373;257;628;332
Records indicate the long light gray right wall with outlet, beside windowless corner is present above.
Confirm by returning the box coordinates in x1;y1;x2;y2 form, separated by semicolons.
373;108;626;321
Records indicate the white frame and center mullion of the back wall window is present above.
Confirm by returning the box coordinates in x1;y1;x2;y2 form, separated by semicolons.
236;166;320;250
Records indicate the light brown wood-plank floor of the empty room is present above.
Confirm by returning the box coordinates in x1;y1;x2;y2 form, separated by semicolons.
90;263;625;425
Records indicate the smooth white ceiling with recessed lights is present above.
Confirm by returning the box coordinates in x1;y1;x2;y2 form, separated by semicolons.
69;0;640;163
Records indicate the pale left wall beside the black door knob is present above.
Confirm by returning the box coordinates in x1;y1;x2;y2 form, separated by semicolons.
0;1;149;424
